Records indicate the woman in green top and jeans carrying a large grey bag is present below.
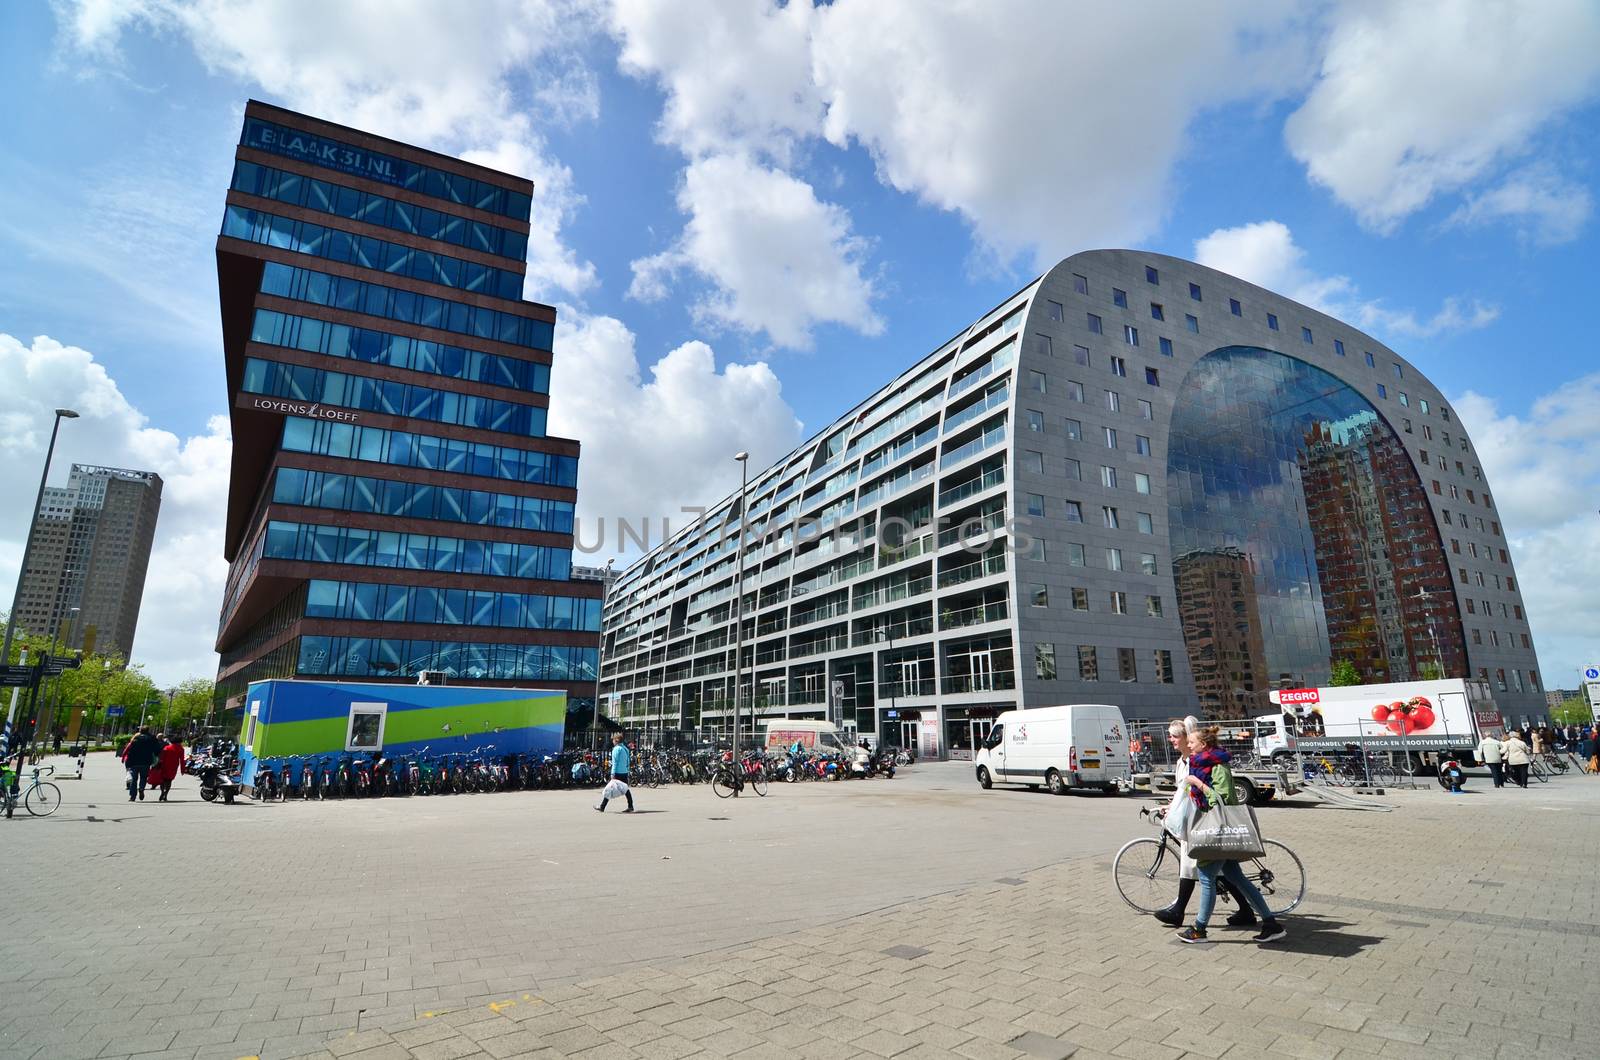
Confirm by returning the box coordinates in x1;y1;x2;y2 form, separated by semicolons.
1178;727;1288;943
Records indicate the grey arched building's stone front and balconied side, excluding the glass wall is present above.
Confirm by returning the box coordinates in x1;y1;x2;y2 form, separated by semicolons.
602;250;1546;754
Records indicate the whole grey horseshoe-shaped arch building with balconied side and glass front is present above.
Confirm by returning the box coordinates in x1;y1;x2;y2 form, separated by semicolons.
600;250;1546;757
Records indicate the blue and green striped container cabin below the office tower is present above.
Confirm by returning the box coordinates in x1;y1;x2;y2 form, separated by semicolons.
238;681;566;785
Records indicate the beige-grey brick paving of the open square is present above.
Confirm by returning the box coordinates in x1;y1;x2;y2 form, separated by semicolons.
0;752;1600;1060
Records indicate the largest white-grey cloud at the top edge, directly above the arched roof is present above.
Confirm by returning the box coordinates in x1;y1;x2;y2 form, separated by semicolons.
813;0;1306;267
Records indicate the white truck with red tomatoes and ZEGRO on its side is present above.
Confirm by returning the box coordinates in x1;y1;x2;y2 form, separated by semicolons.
1256;677;1506;762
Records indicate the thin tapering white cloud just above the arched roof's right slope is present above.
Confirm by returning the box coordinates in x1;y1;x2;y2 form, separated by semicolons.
1195;221;1499;339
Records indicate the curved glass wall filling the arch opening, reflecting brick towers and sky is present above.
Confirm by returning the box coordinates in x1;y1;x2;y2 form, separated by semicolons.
1166;346;1466;717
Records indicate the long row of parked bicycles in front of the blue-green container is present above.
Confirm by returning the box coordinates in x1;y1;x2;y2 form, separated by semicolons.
246;746;896;802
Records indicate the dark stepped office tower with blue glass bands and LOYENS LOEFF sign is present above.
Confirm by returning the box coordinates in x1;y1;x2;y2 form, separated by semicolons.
216;101;602;708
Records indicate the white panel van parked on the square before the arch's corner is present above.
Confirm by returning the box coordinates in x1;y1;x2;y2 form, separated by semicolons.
974;703;1133;794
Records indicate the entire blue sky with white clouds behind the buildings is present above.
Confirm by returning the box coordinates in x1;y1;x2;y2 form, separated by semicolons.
0;0;1600;685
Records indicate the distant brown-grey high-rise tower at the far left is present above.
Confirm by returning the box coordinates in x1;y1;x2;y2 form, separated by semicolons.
16;464;162;658
